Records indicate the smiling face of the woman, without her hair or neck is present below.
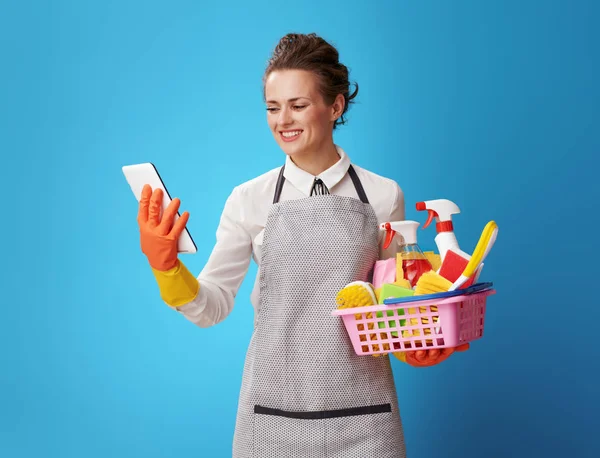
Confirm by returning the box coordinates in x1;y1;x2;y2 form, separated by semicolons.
265;70;343;156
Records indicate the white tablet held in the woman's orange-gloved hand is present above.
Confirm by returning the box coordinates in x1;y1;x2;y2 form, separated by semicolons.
123;162;198;253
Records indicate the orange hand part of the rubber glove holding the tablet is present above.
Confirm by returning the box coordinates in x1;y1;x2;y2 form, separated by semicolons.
137;185;190;271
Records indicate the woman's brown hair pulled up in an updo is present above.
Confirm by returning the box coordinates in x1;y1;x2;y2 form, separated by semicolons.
263;33;358;129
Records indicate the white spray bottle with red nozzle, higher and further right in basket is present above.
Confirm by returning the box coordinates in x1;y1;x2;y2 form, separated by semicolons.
417;199;471;262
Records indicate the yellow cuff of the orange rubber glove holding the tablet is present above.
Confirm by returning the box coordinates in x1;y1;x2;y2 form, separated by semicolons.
152;261;200;307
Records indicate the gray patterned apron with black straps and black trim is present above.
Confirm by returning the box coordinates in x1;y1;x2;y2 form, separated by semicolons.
233;167;406;458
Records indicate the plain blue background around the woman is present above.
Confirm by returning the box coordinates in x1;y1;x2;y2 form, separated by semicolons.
0;0;600;458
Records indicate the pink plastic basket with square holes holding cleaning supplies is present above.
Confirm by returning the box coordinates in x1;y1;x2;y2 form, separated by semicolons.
332;289;496;355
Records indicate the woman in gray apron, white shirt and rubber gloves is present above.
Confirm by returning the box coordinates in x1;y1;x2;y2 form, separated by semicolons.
138;34;464;458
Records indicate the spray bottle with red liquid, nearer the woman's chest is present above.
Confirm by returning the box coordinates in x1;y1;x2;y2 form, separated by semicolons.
379;221;433;288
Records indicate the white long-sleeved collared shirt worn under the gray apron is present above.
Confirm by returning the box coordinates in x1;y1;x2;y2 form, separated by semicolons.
177;146;405;327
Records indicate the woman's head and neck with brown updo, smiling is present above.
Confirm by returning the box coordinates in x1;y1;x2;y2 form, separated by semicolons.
264;34;358;175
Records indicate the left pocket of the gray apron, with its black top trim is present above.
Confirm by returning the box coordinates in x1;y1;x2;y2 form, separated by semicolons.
252;406;326;458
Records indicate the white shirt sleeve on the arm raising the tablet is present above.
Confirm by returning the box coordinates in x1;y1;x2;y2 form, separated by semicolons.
176;187;252;328
